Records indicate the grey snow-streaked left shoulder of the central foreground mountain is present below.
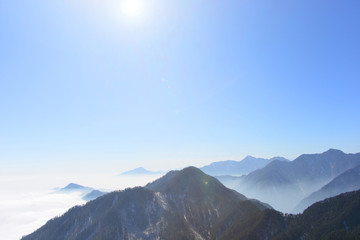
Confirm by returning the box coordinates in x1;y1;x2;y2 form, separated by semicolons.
23;188;195;240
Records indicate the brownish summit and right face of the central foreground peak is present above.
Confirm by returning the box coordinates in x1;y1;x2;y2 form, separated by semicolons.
145;167;268;239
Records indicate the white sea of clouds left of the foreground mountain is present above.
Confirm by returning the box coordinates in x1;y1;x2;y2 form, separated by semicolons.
0;174;161;240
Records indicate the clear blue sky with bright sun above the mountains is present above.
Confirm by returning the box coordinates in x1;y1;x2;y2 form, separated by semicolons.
0;0;360;173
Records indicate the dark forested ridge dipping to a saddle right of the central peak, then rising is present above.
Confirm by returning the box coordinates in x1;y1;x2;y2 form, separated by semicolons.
218;191;360;240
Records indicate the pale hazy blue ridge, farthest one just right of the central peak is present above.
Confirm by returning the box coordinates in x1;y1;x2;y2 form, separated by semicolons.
200;156;289;176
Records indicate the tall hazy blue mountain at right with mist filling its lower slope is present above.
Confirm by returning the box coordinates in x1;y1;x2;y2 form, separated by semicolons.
219;149;360;212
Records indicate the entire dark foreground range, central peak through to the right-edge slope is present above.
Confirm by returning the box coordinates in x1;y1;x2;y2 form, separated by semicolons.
22;167;360;240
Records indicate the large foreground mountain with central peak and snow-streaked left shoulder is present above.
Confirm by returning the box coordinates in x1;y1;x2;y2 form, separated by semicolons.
23;167;267;240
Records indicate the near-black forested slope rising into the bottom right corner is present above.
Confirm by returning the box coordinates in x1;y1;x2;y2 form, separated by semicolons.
275;191;360;240
